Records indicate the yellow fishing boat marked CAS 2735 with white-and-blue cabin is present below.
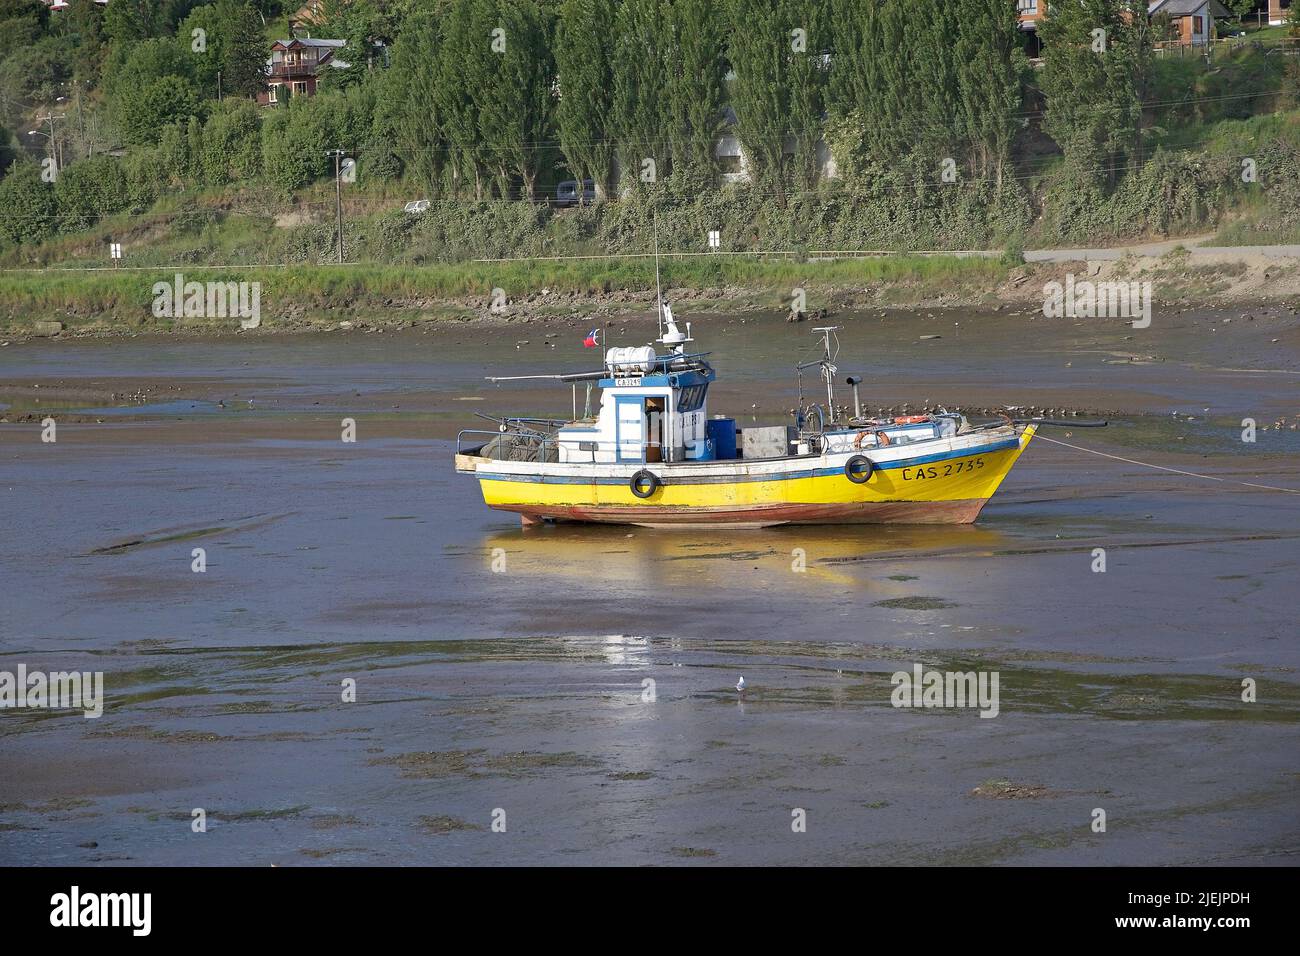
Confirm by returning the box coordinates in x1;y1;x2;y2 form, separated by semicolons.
456;287;1055;528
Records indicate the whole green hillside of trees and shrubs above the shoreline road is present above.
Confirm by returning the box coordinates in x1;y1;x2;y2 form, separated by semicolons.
0;0;1300;312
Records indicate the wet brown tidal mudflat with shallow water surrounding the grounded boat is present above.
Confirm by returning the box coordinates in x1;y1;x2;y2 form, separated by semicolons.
0;312;1300;865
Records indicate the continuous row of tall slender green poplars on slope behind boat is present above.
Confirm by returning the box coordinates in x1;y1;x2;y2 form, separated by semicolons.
393;0;1027;196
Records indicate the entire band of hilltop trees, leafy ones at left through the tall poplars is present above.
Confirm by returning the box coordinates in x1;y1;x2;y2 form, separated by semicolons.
0;0;1289;251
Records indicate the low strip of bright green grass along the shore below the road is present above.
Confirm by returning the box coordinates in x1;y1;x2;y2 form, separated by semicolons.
0;256;1011;334
